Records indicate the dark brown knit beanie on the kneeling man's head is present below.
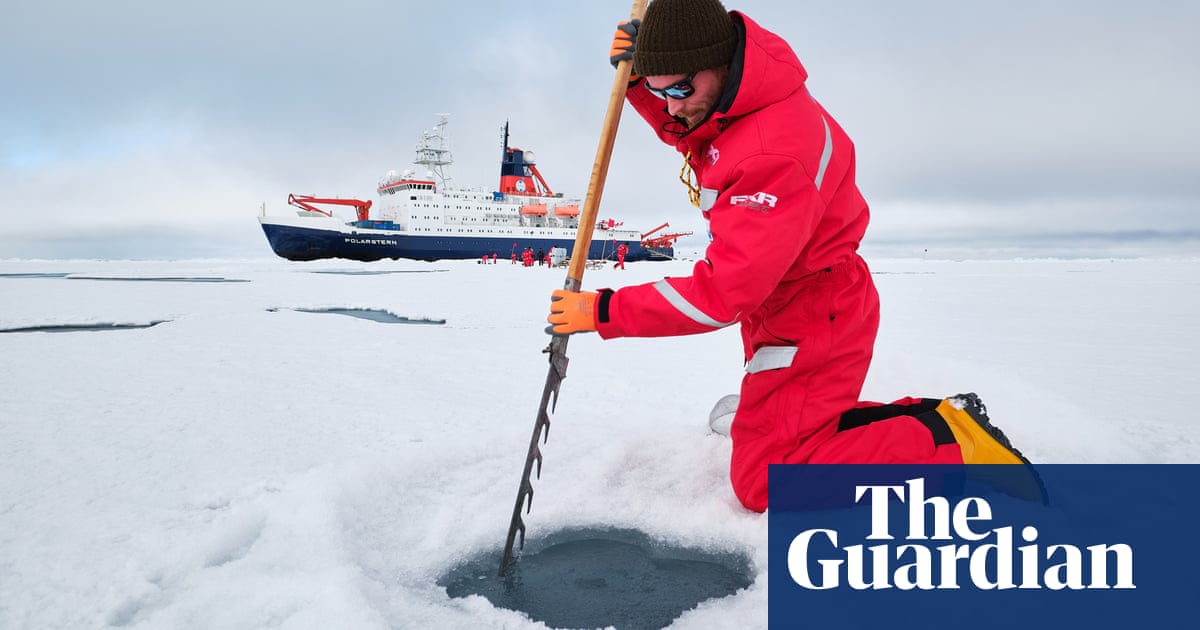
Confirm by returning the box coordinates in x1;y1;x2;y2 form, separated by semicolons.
634;0;738;77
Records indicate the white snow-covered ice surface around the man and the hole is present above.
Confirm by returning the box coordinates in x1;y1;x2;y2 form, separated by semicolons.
0;253;1200;629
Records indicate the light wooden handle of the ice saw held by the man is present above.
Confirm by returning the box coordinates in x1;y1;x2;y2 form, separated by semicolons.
564;0;647;285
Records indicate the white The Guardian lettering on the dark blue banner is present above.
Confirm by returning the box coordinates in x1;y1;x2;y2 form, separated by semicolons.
786;479;1136;590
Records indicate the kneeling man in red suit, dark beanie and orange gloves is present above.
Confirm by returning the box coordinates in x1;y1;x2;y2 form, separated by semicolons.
547;0;1022;511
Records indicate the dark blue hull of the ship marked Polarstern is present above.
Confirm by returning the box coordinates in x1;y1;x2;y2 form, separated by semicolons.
263;222;674;262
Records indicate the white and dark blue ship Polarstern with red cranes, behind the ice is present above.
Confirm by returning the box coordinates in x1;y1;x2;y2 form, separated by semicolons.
259;115;691;262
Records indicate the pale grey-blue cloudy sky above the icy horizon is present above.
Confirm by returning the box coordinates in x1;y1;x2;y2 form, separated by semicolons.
0;0;1200;258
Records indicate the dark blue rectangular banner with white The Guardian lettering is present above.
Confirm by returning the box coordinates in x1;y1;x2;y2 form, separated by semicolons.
768;464;1200;630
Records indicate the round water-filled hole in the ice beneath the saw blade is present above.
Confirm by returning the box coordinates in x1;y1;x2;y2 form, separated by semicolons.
438;528;754;630
